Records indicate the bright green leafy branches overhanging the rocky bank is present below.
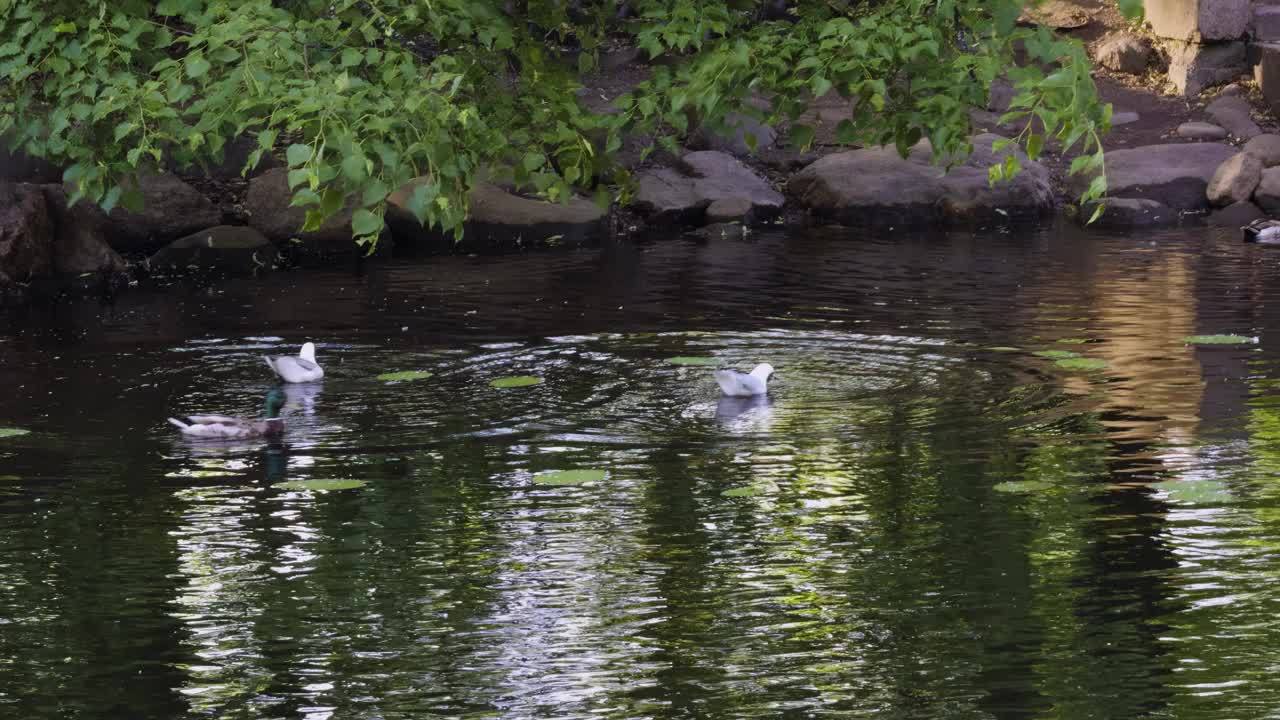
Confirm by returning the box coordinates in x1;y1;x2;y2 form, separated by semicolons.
0;0;1140;243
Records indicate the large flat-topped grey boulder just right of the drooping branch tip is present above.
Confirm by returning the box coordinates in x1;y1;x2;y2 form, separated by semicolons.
1068;142;1236;211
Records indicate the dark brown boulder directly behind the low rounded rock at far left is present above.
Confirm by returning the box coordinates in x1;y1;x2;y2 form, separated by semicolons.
108;174;223;252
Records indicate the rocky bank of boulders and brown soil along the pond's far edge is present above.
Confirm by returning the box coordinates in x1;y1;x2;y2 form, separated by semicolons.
0;0;1280;302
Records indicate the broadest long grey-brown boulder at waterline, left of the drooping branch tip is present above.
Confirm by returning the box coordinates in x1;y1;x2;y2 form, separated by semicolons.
787;133;1053;227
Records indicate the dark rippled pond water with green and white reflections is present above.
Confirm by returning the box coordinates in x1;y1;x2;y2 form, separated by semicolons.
0;221;1280;720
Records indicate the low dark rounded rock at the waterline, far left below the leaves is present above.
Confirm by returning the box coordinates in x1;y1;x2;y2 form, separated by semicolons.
147;225;278;274
